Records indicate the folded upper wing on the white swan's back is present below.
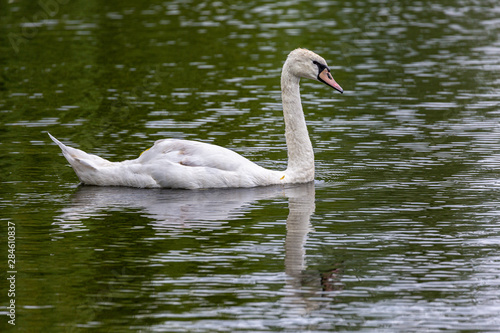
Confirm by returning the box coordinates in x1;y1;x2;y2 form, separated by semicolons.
136;139;256;171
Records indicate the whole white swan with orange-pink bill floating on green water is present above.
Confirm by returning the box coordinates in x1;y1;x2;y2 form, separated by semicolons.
48;48;343;189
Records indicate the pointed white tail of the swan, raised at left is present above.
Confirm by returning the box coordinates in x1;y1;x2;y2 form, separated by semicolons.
47;133;113;184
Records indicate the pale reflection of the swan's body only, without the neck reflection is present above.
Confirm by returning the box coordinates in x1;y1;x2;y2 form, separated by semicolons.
54;185;294;232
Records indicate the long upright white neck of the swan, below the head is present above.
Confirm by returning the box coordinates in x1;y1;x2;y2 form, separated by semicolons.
281;63;314;182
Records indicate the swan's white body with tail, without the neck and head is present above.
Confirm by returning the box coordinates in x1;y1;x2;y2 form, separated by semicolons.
53;134;283;189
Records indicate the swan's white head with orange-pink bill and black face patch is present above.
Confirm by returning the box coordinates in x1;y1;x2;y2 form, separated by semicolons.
286;49;344;93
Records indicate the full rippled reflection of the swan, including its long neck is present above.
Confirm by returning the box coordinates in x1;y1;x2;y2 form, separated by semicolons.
53;183;338;312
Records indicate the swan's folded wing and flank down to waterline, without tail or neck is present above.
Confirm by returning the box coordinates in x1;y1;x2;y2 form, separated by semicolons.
126;139;282;189
